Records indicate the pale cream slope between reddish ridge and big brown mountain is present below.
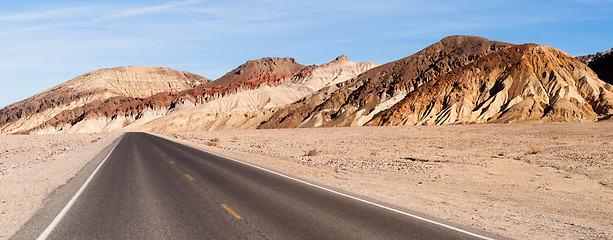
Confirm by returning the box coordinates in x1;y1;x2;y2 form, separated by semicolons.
140;55;380;131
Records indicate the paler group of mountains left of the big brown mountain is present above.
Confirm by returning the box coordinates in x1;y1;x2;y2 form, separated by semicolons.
0;56;378;134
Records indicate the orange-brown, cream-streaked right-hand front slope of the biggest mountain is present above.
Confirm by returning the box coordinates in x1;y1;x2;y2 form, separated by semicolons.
367;44;613;126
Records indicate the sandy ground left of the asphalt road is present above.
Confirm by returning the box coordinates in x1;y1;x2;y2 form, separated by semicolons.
0;133;120;239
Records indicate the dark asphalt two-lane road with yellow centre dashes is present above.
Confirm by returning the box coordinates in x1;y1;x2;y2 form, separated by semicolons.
13;133;498;239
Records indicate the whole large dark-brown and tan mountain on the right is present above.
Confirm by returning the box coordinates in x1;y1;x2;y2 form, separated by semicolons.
259;36;613;128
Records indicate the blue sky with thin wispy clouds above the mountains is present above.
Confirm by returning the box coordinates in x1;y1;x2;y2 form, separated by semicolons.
0;0;613;108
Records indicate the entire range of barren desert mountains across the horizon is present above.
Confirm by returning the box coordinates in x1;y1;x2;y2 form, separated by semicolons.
0;36;613;134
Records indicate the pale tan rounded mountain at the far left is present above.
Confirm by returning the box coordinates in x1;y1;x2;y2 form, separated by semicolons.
0;67;210;133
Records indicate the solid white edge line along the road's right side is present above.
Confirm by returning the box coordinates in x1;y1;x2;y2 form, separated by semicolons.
185;140;494;240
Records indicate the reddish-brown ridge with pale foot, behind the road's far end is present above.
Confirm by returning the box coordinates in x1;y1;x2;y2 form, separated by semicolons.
10;58;313;133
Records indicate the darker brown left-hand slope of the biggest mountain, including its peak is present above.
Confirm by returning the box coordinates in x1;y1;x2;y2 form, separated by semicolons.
259;36;513;128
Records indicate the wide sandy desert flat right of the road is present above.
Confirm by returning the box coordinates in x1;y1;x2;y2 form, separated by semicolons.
164;122;613;239
